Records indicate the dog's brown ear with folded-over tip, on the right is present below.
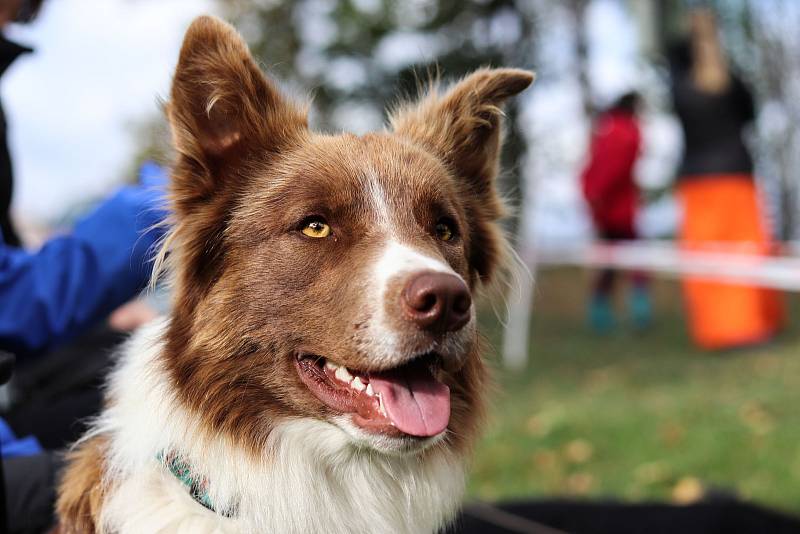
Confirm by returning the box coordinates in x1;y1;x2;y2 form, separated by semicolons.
390;69;534;199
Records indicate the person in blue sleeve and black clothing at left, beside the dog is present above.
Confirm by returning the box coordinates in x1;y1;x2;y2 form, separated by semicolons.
0;0;166;533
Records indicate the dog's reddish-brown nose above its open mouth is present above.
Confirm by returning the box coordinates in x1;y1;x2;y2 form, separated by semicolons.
401;271;472;333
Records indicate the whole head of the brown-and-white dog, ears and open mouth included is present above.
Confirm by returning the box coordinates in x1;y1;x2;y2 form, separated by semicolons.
165;17;532;458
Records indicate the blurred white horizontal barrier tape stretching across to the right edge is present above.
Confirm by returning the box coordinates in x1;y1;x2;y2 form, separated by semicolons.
523;241;800;291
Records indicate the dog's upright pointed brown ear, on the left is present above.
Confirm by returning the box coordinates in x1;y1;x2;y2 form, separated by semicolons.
167;16;307;186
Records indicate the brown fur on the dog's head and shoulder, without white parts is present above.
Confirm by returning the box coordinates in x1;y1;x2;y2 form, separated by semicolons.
59;17;532;531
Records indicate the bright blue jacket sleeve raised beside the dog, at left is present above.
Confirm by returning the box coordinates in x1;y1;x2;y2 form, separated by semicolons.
0;164;166;359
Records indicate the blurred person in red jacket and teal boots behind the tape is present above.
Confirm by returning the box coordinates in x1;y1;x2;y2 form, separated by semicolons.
581;92;651;332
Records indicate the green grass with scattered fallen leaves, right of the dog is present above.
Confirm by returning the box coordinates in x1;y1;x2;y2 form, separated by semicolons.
469;270;800;511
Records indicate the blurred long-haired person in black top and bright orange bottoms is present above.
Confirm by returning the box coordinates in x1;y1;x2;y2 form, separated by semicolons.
671;8;783;349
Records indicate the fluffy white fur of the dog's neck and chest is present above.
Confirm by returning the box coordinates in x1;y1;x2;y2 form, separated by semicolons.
95;324;464;534
